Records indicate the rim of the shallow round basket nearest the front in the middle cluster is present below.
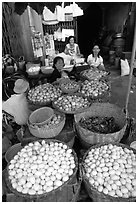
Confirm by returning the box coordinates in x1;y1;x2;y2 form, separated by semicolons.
52;93;91;114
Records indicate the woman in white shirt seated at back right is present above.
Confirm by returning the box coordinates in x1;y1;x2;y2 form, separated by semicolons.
87;45;105;70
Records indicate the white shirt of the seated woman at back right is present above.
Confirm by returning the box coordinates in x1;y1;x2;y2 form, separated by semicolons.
87;54;104;67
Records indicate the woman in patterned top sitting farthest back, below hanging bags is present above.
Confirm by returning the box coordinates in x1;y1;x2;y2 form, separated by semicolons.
64;36;82;57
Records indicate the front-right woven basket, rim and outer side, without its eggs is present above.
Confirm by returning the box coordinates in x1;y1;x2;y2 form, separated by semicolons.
80;143;136;202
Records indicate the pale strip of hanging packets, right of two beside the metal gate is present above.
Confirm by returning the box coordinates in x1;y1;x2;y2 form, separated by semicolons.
44;33;55;55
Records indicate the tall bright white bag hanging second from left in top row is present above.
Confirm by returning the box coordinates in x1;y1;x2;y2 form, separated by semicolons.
55;2;65;22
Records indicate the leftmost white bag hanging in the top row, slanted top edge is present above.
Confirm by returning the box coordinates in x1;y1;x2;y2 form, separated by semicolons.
42;6;58;25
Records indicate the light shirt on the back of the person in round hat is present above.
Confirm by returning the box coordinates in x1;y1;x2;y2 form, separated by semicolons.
2;93;29;125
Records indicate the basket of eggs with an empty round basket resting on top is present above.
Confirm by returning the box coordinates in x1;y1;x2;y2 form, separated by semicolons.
28;107;65;138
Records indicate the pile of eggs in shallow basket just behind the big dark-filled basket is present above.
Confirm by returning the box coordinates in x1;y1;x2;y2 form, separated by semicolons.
81;80;109;98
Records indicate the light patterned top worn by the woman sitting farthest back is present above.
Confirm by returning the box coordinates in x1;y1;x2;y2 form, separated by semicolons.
65;43;80;56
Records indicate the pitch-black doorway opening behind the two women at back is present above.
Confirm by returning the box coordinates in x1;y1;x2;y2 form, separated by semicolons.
77;2;102;58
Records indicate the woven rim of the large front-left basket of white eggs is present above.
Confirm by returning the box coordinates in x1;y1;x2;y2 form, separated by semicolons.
6;138;78;199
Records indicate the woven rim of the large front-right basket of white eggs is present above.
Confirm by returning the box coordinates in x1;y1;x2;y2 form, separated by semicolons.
80;142;136;201
